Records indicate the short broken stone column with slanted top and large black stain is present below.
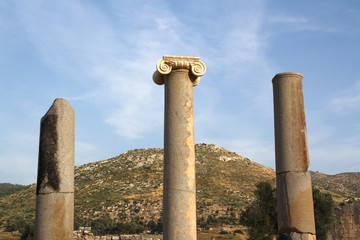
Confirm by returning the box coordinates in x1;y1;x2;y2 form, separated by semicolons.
35;98;75;240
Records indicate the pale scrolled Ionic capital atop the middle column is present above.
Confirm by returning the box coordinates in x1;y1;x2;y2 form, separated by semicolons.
153;55;206;86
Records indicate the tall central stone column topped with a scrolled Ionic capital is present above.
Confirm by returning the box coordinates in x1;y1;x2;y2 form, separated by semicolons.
153;56;206;240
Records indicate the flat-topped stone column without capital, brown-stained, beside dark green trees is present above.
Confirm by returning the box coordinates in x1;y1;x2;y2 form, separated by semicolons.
272;72;316;240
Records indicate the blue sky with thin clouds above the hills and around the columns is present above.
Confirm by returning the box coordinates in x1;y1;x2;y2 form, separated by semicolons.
0;0;360;184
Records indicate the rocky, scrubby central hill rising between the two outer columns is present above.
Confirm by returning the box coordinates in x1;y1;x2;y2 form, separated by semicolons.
75;144;275;226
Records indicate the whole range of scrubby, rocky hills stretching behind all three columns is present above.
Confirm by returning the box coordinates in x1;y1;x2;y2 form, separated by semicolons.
0;144;360;236
